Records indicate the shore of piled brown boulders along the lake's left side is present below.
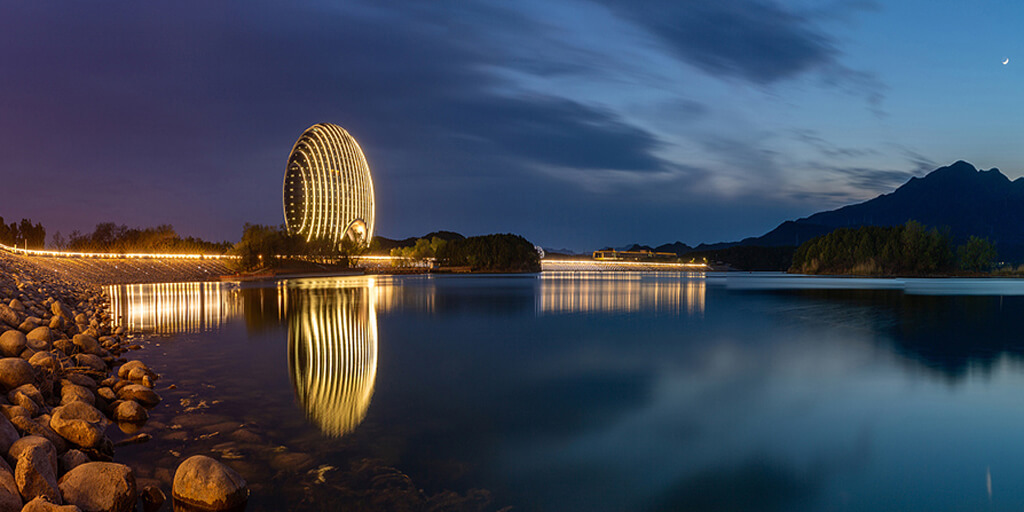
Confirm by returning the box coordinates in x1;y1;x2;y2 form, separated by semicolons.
0;254;249;511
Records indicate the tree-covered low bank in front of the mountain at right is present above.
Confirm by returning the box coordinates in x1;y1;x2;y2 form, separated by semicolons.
790;220;995;275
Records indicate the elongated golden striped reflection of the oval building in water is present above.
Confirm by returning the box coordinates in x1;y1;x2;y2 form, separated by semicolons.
279;280;377;436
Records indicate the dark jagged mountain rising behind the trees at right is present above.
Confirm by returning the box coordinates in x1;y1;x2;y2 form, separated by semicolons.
741;161;1024;261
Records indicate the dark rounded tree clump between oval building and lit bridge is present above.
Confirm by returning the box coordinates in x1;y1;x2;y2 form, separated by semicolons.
436;233;541;272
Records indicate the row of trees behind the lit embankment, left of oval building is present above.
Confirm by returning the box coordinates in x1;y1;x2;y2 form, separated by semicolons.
64;222;231;254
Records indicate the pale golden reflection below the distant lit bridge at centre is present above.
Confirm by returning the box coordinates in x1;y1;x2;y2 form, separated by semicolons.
538;271;706;315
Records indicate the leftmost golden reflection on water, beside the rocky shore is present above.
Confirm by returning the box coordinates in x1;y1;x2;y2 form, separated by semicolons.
106;283;242;334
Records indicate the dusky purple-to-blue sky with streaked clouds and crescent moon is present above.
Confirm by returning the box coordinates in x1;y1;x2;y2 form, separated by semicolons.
0;0;1024;251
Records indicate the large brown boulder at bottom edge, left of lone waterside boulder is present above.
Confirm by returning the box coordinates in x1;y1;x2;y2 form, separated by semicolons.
60;462;138;512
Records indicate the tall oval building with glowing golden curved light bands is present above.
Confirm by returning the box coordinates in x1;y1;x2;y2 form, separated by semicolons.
284;123;374;245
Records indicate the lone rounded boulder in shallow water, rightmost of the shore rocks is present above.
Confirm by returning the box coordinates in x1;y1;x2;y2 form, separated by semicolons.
171;455;249;511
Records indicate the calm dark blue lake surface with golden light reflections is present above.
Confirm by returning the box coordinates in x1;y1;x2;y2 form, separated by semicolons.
103;273;1024;511
